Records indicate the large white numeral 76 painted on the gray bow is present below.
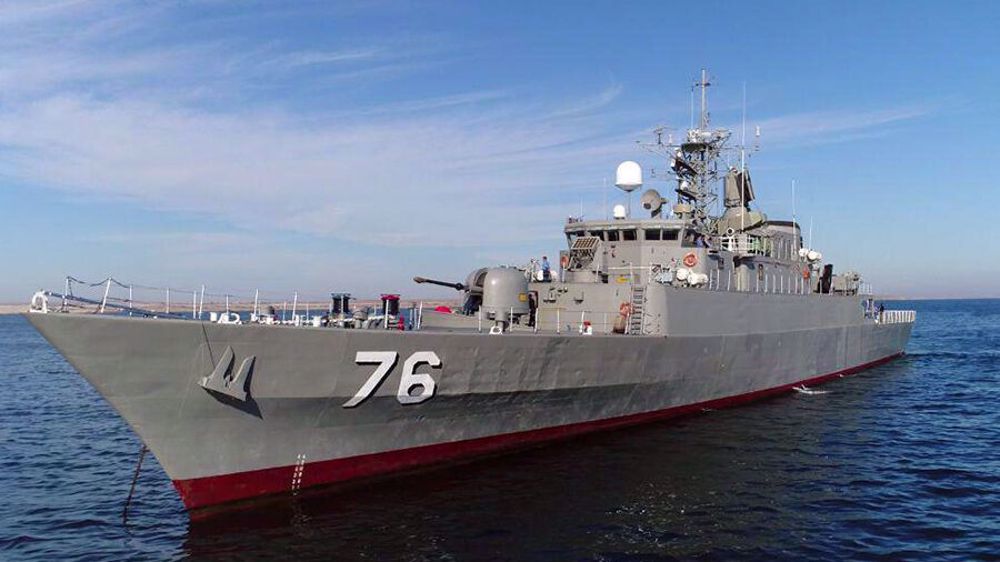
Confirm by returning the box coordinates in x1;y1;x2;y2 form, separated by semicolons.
343;351;441;408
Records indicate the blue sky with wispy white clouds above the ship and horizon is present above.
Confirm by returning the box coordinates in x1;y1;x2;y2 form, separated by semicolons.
0;1;1000;302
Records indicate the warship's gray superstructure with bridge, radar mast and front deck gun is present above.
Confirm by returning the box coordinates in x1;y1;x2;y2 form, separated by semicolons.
417;70;874;335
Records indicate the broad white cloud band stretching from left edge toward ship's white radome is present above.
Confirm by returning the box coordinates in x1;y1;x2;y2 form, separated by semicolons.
0;87;627;245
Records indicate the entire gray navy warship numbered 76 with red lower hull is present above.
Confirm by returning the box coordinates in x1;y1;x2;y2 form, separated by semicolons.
26;72;915;513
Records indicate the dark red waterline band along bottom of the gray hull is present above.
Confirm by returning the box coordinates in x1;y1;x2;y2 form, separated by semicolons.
174;353;902;510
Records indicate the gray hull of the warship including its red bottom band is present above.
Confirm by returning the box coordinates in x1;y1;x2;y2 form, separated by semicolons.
27;296;912;510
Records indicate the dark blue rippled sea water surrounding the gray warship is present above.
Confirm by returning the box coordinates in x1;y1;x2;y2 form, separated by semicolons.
0;301;1000;560
